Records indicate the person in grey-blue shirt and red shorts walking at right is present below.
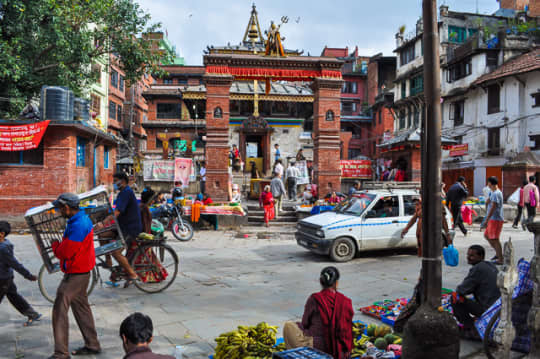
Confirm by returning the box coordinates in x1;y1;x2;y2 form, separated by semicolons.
480;177;504;265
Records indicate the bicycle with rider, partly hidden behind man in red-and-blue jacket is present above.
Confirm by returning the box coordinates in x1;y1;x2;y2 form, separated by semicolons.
38;227;179;303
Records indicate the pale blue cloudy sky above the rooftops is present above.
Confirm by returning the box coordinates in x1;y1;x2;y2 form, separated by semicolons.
136;0;499;65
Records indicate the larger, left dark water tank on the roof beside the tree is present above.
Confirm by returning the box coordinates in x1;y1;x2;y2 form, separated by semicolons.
40;86;74;121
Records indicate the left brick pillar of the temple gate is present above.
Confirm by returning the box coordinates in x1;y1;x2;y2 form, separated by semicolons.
204;74;233;201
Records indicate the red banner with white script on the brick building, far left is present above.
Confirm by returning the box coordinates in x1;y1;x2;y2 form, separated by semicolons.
0;121;50;151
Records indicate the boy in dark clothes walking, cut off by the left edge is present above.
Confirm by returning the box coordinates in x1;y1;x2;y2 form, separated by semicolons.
0;221;41;326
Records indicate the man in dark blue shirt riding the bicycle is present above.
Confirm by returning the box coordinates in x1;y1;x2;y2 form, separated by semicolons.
113;172;142;286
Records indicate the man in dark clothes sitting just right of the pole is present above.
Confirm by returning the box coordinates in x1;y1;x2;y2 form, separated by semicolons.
452;244;501;331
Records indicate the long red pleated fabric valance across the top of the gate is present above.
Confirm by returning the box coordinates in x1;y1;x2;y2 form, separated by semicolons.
206;66;341;81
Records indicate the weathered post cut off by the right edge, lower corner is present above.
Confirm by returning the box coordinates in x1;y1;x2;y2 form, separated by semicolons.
527;222;540;358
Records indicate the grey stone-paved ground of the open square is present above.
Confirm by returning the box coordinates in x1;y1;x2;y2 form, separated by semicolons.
0;225;532;359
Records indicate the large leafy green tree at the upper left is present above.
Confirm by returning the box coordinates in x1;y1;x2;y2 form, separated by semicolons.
0;0;170;118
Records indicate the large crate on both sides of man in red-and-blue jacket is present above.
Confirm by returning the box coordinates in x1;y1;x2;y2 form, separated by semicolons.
24;186;125;273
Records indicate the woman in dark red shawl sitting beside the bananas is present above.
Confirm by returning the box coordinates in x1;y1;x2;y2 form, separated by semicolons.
283;267;354;359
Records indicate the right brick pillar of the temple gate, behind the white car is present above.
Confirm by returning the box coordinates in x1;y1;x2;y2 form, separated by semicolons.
311;78;343;197
